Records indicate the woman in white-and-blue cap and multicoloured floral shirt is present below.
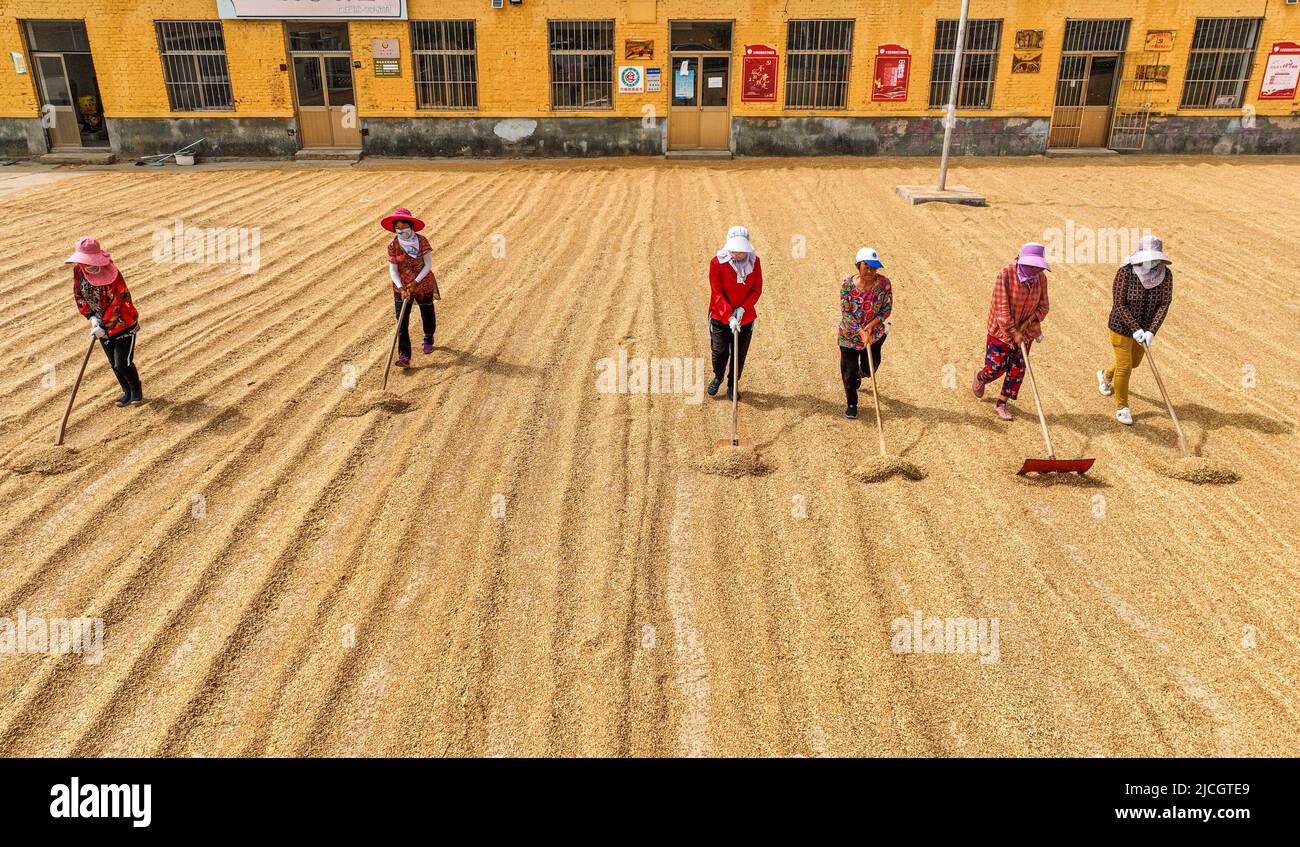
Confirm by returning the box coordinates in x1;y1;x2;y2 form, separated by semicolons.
840;247;893;418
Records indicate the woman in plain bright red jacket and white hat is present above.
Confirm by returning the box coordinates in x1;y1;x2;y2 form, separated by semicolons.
707;226;763;400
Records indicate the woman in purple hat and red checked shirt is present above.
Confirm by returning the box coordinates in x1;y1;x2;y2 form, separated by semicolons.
972;242;1050;421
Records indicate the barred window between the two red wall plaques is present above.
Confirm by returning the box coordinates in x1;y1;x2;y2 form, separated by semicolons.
785;21;853;109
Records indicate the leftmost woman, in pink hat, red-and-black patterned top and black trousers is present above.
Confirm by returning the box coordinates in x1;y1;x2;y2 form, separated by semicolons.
65;238;144;405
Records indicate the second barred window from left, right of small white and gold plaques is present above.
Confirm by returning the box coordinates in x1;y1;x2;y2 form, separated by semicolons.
411;21;478;109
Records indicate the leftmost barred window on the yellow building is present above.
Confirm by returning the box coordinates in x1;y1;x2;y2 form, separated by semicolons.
155;21;235;112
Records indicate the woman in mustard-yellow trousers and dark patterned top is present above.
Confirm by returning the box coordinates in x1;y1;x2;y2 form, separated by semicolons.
1097;235;1174;426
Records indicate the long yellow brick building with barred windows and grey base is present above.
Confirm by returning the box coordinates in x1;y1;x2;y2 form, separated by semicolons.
0;0;1300;156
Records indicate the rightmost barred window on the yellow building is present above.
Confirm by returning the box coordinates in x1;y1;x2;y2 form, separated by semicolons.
1180;18;1262;109
